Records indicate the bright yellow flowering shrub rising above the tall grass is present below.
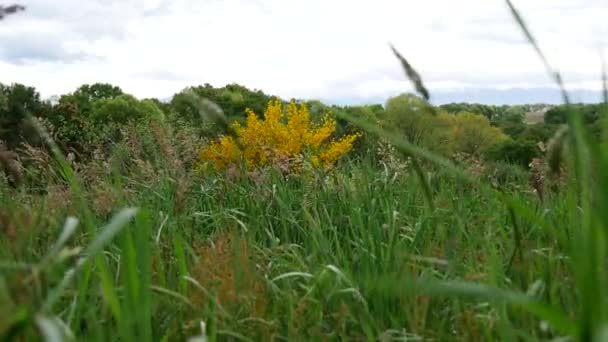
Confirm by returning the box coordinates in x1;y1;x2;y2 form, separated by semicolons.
199;100;359;171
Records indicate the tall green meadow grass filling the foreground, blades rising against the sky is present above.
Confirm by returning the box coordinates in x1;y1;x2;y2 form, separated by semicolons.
0;2;608;341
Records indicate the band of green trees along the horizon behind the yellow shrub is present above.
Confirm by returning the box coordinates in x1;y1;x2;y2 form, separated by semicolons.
0;83;606;170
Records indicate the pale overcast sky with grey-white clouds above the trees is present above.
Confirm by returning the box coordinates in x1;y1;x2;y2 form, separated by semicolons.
0;0;608;103
